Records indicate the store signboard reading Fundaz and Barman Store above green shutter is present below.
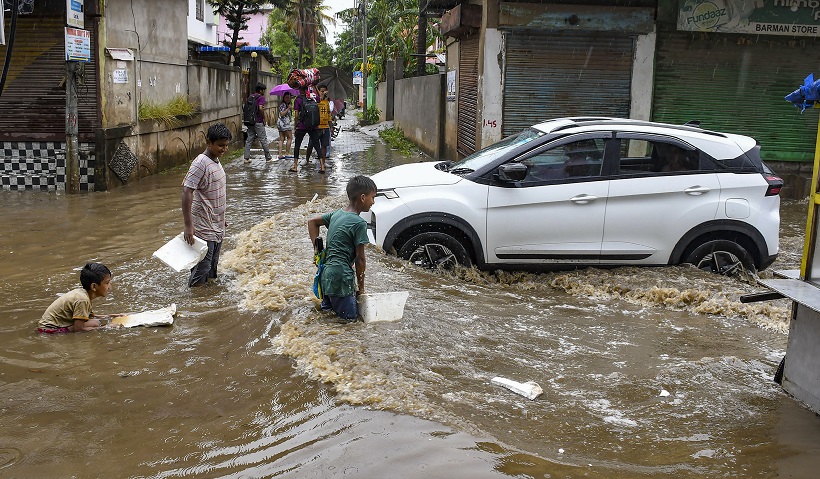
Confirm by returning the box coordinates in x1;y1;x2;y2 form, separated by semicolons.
678;0;820;37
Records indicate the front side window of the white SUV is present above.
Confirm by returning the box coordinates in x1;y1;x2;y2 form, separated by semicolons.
521;139;604;186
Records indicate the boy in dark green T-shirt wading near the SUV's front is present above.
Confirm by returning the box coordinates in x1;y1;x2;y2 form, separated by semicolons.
308;176;376;323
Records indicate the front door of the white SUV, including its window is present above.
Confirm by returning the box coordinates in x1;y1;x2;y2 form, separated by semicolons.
485;133;609;264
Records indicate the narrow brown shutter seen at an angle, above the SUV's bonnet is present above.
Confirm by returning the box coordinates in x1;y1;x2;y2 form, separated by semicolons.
456;35;479;156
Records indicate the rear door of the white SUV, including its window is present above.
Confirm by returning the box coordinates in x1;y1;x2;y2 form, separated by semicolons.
601;133;720;264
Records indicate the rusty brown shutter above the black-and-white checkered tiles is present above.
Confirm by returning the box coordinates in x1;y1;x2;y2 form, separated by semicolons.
0;16;99;142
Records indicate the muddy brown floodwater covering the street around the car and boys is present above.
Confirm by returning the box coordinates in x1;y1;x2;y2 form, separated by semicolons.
0;124;820;479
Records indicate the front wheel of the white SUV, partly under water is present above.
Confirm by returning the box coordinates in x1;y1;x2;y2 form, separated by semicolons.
399;232;472;269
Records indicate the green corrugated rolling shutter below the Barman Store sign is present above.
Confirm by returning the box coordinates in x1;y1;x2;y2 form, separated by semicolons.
652;32;820;161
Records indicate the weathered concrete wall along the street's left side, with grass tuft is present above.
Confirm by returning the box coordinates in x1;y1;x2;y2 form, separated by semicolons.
94;0;276;190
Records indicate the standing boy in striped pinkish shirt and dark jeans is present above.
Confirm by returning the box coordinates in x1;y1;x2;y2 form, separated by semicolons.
182;123;232;288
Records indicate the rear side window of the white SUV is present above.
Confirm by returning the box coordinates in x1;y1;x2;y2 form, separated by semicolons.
618;139;700;176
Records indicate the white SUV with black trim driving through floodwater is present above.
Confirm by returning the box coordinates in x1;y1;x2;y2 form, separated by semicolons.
363;117;783;274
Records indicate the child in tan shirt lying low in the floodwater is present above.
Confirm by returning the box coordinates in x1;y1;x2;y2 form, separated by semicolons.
37;263;119;333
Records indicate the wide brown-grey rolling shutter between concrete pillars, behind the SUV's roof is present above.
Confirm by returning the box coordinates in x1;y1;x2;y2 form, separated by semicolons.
501;30;635;137
